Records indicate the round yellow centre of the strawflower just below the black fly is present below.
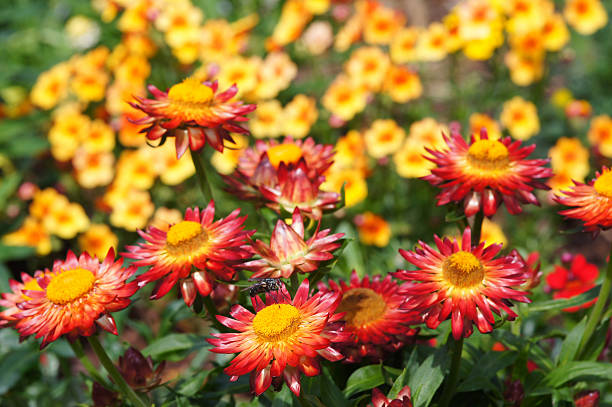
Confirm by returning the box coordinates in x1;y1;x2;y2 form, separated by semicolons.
253;304;301;342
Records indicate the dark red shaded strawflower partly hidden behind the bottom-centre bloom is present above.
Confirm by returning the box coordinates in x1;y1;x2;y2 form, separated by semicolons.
319;270;423;363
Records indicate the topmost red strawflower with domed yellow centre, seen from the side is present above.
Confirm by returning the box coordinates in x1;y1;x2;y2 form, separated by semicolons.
130;78;256;158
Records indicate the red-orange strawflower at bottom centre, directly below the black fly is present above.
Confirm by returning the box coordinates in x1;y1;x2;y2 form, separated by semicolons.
208;279;349;396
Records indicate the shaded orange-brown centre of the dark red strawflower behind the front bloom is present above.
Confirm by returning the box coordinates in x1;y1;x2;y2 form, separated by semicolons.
337;288;387;328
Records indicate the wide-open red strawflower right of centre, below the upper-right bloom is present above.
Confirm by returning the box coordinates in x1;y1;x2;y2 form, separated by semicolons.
394;228;530;339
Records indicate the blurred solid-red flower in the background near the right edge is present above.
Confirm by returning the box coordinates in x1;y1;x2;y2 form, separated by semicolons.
546;254;599;312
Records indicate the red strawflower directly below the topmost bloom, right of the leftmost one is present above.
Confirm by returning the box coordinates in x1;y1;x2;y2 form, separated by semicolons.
123;201;255;306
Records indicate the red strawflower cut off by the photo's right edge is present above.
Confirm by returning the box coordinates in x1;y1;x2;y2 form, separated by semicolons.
553;167;612;231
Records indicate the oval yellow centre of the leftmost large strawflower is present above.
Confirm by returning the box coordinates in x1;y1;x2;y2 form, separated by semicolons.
47;267;96;305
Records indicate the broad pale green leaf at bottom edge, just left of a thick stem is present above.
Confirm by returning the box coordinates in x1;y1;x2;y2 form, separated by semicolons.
408;347;448;407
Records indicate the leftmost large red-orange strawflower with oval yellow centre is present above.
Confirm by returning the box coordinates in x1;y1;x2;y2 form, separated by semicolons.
5;249;138;348
